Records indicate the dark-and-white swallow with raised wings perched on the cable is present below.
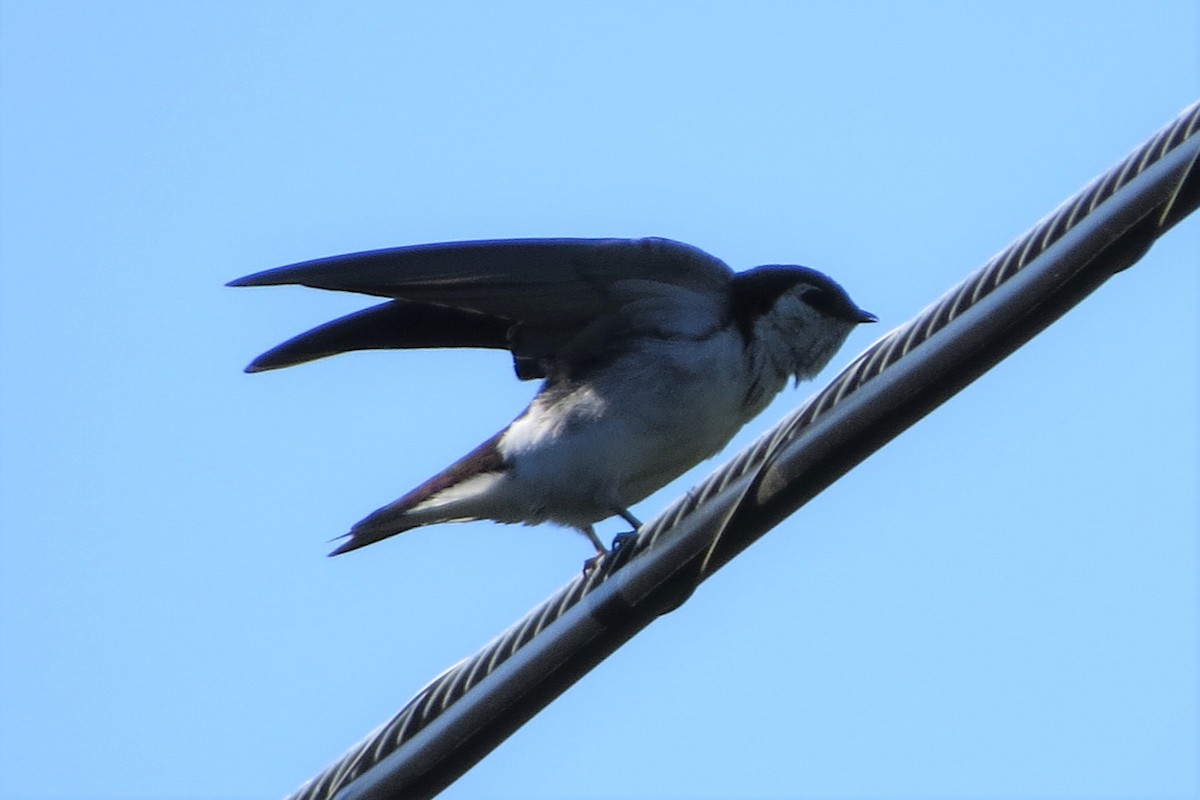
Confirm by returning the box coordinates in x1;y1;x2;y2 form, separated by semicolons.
227;237;877;558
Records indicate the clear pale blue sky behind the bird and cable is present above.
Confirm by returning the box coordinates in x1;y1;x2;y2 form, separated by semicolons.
0;1;1200;800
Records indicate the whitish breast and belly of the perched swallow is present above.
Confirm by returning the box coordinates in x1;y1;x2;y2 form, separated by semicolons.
499;329;784;527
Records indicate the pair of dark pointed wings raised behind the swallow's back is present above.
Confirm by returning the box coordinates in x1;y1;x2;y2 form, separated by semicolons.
229;239;732;378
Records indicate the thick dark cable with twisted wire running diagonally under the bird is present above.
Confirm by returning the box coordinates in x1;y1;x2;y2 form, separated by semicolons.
288;103;1200;800
